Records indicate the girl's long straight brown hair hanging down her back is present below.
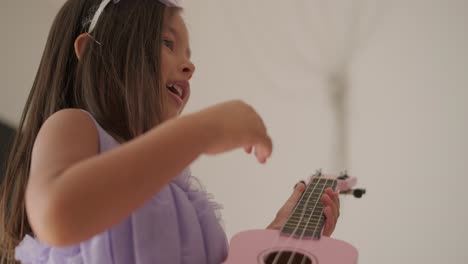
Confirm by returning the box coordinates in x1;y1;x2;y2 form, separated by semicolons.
0;0;176;264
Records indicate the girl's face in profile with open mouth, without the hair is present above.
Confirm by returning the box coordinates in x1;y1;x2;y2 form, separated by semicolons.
161;12;195;120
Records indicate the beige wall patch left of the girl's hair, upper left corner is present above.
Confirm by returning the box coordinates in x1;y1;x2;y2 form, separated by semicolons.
0;0;60;124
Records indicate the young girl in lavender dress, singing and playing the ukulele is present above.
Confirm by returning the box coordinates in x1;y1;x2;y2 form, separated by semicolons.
0;0;339;264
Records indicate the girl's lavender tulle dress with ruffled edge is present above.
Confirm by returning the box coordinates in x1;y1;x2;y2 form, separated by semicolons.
15;112;227;264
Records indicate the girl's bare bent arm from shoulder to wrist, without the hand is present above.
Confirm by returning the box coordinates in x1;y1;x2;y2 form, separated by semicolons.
26;110;210;246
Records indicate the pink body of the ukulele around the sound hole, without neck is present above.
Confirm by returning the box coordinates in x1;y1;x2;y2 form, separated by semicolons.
224;230;358;264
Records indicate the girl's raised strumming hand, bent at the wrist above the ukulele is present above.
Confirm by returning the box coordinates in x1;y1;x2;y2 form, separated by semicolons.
198;100;272;163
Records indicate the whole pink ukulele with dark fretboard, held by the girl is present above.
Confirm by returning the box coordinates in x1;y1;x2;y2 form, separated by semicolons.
224;171;365;264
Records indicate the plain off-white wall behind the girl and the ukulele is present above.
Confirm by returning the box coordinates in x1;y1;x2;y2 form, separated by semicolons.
0;0;468;264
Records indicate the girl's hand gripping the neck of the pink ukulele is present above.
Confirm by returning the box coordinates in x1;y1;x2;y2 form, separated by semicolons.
267;182;340;237
